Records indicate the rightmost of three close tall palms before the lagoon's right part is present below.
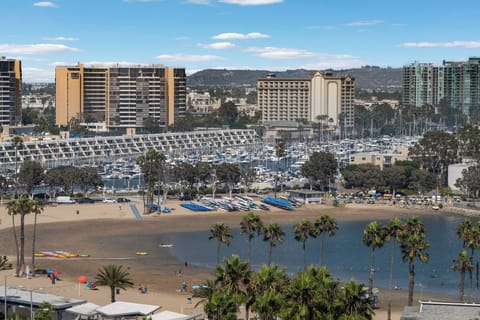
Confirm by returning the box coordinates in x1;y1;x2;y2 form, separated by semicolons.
400;217;430;307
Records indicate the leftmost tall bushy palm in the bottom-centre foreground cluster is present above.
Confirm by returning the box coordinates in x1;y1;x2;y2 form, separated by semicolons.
215;255;253;320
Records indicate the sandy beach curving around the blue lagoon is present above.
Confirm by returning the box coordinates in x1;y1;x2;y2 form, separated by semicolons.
0;199;462;320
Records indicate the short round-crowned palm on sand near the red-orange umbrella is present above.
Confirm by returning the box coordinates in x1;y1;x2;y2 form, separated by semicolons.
95;264;133;302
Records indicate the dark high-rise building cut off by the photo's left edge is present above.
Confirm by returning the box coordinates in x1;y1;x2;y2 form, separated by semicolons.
0;57;22;126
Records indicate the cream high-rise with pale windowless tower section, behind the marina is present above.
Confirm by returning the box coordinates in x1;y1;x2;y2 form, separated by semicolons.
257;72;355;128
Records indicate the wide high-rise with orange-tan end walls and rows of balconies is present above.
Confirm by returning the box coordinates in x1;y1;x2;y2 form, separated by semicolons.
55;64;186;131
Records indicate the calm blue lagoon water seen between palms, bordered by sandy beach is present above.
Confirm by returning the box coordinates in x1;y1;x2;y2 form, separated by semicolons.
160;215;472;295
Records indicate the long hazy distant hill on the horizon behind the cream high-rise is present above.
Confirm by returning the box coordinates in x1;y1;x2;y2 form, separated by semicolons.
187;66;402;91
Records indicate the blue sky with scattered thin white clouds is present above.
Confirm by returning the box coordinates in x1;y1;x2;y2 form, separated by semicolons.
0;0;480;82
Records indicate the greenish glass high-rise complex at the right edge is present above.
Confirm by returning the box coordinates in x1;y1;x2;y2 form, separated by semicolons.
402;58;480;115
